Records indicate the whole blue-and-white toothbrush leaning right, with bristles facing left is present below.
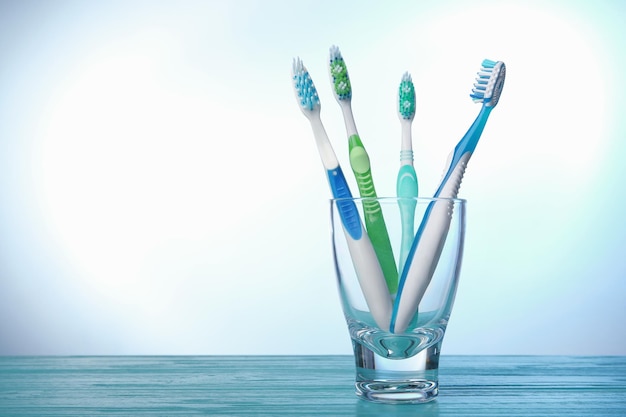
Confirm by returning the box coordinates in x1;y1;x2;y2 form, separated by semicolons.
390;59;506;333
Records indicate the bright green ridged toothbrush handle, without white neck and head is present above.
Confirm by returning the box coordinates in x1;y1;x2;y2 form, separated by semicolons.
348;134;398;294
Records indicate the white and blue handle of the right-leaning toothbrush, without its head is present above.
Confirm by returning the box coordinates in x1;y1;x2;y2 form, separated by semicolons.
390;152;472;333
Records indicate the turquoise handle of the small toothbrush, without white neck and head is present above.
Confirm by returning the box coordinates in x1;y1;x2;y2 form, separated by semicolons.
396;165;418;271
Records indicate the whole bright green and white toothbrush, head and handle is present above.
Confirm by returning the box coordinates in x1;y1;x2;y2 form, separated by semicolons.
328;46;398;295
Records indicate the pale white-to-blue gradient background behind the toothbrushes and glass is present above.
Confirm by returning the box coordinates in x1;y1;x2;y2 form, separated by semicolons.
0;0;626;355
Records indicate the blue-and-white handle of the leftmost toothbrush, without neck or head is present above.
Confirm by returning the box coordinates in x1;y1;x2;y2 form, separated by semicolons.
327;166;392;331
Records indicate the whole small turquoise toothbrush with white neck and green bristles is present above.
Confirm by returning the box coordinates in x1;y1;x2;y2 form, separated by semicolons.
396;72;418;271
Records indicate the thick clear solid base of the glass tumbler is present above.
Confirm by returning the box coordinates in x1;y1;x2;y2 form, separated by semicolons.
353;342;440;404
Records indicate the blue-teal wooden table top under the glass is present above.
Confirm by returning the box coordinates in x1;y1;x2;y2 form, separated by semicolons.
0;355;626;417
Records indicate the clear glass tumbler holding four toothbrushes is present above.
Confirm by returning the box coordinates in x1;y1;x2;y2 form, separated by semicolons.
331;198;466;403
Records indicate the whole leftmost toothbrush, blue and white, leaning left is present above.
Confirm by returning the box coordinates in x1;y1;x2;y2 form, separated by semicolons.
292;58;392;331
